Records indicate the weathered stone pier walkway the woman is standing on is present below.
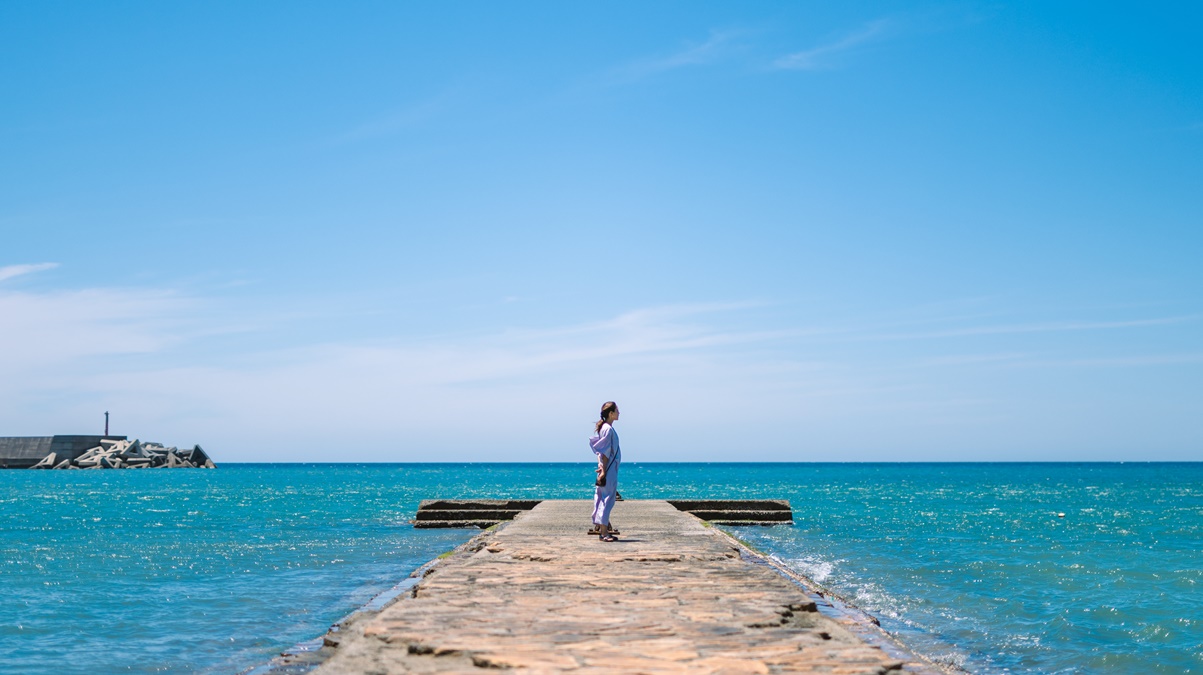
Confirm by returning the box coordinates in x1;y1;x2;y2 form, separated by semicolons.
316;501;928;675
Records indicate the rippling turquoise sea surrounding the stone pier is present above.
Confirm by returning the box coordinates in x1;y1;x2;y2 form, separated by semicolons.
0;463;1203;674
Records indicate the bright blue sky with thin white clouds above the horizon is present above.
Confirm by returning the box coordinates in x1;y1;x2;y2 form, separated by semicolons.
0;2;1203;461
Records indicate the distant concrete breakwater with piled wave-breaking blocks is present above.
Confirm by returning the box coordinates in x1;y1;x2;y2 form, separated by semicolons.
0;436;217;469
